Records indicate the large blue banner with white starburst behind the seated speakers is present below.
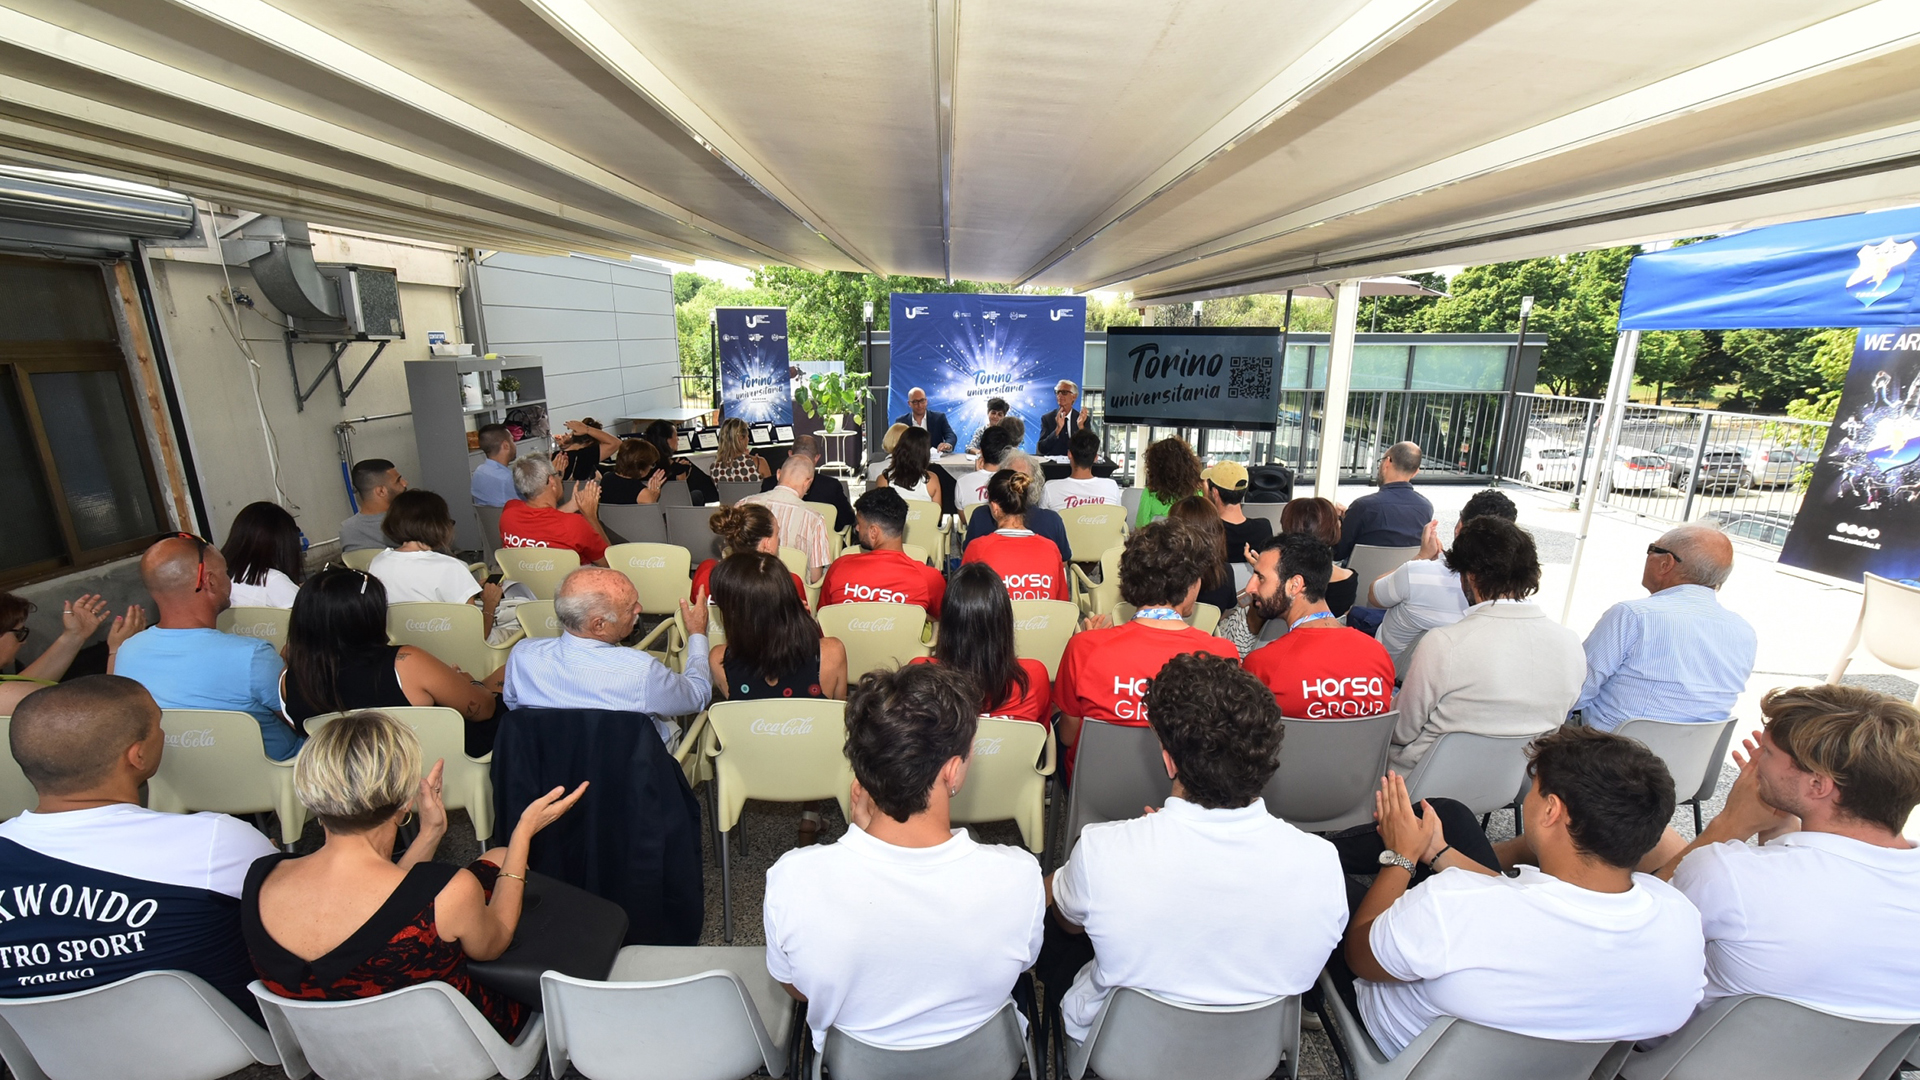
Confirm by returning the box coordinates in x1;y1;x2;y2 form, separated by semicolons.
887;292;1087;450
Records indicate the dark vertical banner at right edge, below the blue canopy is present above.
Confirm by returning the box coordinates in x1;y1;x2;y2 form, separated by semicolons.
1780;327;1920;580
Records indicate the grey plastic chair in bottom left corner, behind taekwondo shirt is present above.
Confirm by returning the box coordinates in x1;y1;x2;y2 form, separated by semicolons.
0;970;280;1080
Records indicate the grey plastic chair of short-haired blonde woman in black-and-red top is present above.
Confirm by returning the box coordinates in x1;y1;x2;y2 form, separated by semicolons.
248;980;547;1080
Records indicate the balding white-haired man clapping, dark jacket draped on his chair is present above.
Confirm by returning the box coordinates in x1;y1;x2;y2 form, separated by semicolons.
501;564;714;749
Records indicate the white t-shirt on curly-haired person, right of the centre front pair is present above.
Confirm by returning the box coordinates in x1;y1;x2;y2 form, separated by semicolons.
1054;798;1346;1042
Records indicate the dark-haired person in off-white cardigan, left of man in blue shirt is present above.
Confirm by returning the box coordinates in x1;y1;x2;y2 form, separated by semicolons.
1390;517;1586;773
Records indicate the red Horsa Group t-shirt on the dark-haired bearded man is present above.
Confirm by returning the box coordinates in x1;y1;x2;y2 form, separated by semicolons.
1244;625;1394;721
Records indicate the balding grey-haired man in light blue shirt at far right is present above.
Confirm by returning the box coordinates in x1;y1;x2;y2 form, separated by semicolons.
1574;525;1759;732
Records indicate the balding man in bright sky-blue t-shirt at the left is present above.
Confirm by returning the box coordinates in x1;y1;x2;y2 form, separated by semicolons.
113;536;305;761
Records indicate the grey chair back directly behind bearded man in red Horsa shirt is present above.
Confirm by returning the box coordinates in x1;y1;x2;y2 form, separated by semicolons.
1261;713;1400;832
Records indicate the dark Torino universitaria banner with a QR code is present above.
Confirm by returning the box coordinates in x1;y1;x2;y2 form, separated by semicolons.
1106;327;1281;430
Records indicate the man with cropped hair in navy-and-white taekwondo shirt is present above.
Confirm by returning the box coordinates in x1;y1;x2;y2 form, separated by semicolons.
0;675;273;1006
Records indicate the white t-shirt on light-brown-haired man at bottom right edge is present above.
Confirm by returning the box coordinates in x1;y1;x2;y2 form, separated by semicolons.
1674;832;1920;1024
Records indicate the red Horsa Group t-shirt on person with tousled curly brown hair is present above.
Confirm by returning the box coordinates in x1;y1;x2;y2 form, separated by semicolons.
1054;619;1240;728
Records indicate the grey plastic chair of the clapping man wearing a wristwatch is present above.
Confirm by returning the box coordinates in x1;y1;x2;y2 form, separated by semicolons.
1319;972;1632;1080
